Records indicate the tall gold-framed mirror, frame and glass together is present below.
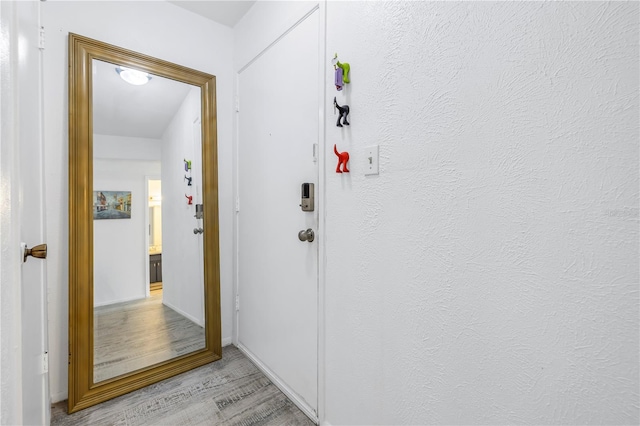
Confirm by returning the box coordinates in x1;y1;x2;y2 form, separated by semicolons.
68;34;221;413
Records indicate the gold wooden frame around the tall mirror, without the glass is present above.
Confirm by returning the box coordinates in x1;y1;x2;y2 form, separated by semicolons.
68;33;222;413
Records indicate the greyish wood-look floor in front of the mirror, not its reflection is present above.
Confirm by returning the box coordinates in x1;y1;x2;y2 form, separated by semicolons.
51;346;313;426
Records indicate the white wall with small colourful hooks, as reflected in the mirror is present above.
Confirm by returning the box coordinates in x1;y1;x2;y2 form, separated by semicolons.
162;88;204;325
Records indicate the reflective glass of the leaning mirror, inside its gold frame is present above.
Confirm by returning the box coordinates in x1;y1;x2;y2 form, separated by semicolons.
92;59;205;383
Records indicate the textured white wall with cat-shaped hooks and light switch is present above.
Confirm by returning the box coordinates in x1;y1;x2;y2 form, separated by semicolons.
324;2;639;424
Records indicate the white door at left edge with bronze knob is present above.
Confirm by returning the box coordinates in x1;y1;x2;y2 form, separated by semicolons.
0;2;50;425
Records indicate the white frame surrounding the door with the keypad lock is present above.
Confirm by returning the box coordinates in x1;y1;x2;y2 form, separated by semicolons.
232;1;331;424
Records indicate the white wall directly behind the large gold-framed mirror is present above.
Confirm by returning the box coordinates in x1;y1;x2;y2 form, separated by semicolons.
42;0;233;401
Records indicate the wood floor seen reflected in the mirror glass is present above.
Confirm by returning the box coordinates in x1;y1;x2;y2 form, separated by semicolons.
93;290;205;383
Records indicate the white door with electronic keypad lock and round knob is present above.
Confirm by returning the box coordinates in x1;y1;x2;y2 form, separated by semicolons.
237;11;319;418
